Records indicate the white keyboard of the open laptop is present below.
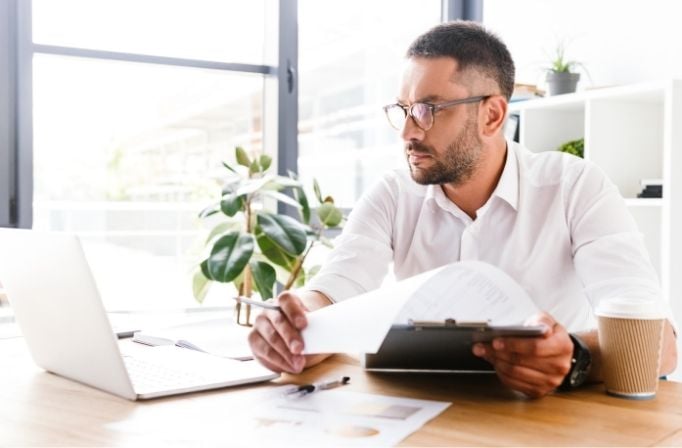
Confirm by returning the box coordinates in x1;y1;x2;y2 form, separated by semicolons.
123;356;211;392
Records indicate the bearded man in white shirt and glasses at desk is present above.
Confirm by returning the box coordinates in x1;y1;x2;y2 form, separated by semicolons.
249;22;677;397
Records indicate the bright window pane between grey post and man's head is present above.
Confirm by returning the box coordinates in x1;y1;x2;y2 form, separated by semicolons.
298;0;441;207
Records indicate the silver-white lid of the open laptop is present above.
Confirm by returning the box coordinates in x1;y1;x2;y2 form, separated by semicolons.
0;229;136;399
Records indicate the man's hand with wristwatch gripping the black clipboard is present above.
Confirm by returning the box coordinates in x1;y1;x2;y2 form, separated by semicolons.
473;313;573;398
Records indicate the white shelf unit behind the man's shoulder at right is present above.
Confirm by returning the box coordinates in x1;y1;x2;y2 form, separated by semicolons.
509;80;682;325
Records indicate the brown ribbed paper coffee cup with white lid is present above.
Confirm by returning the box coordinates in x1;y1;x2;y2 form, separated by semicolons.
596;298;665;400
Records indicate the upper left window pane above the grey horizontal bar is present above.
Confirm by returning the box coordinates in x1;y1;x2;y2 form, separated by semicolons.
33;0;276;64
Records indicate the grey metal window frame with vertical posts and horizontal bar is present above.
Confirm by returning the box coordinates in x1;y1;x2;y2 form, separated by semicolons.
0;0;483;228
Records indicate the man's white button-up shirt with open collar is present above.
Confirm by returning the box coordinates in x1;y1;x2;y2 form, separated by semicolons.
306;142;672;332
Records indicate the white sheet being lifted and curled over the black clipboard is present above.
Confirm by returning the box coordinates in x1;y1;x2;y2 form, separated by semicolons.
302;261;538;354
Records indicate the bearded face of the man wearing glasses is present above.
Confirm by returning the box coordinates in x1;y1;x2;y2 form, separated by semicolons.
399;57;485;186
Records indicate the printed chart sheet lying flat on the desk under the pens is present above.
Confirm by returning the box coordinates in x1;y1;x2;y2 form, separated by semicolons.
105;386;451;448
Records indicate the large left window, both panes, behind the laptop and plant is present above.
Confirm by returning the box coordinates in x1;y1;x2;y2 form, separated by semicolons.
32;0;276;309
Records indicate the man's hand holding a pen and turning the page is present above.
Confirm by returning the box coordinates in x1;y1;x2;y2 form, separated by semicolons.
249;291;331;373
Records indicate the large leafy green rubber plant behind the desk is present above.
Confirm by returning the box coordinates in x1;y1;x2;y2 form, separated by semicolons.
192;147;343;325
